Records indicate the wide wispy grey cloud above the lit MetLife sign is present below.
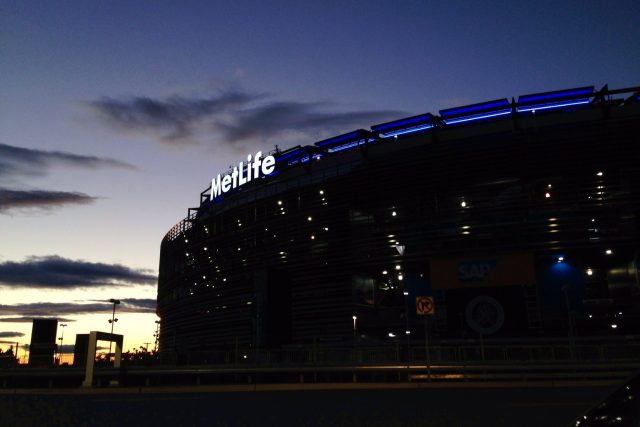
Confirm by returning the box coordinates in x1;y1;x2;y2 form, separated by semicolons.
89;91;407;145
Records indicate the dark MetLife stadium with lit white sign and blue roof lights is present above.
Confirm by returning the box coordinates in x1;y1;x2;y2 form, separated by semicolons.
158;86;640;354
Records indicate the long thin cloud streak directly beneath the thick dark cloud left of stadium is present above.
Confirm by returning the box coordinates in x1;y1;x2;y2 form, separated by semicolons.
0;299;156;322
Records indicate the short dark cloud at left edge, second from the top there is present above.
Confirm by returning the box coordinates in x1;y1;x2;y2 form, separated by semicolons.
0;188;97;214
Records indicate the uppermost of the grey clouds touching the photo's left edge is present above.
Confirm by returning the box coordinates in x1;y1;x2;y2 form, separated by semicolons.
0;143;135;178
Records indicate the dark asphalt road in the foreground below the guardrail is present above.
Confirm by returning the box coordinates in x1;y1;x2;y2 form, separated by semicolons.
0;387;607;427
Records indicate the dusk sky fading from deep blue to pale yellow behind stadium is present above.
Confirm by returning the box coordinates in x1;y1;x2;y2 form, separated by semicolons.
0;0;640;350
